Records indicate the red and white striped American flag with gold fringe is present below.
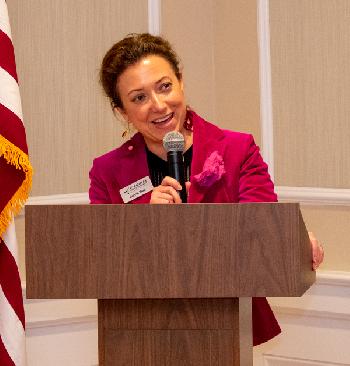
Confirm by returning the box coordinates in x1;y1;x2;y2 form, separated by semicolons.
0;0;32;366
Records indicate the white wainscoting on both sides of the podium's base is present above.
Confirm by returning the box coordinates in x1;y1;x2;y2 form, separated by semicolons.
24;271;350;366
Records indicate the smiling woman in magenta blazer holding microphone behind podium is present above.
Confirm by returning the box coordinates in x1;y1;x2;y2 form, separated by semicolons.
89;34;323;345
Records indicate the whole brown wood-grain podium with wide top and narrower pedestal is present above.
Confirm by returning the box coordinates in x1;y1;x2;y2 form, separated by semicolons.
26;203;315;366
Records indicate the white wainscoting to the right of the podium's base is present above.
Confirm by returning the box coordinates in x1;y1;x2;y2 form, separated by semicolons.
254;271;350;366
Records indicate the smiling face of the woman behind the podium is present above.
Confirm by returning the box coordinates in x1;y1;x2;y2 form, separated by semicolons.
116;55;186;146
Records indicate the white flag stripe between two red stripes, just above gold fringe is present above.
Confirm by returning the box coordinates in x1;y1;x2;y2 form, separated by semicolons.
0;67;23;120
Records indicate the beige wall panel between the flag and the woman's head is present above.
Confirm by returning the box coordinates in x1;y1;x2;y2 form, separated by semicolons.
8;0;147;196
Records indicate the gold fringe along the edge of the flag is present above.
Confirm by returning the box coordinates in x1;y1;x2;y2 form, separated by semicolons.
0;135;33;237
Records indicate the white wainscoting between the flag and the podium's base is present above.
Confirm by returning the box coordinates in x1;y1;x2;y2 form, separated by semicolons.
23;292;98;366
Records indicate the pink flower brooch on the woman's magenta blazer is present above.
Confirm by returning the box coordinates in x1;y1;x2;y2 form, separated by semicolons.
193;151;225;187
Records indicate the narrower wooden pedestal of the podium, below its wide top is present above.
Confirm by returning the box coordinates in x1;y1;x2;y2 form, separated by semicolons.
98;299;252;366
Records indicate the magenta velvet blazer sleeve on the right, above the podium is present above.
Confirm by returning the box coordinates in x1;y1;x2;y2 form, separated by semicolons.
238;135;277;202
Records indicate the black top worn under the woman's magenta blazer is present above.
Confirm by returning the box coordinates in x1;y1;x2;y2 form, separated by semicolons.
146;146;192;187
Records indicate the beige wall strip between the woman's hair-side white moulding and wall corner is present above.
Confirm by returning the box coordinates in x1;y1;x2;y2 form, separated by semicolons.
161;0;215;121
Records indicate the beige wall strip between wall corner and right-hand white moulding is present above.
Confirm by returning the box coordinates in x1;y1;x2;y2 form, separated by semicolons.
213;0;260;143
